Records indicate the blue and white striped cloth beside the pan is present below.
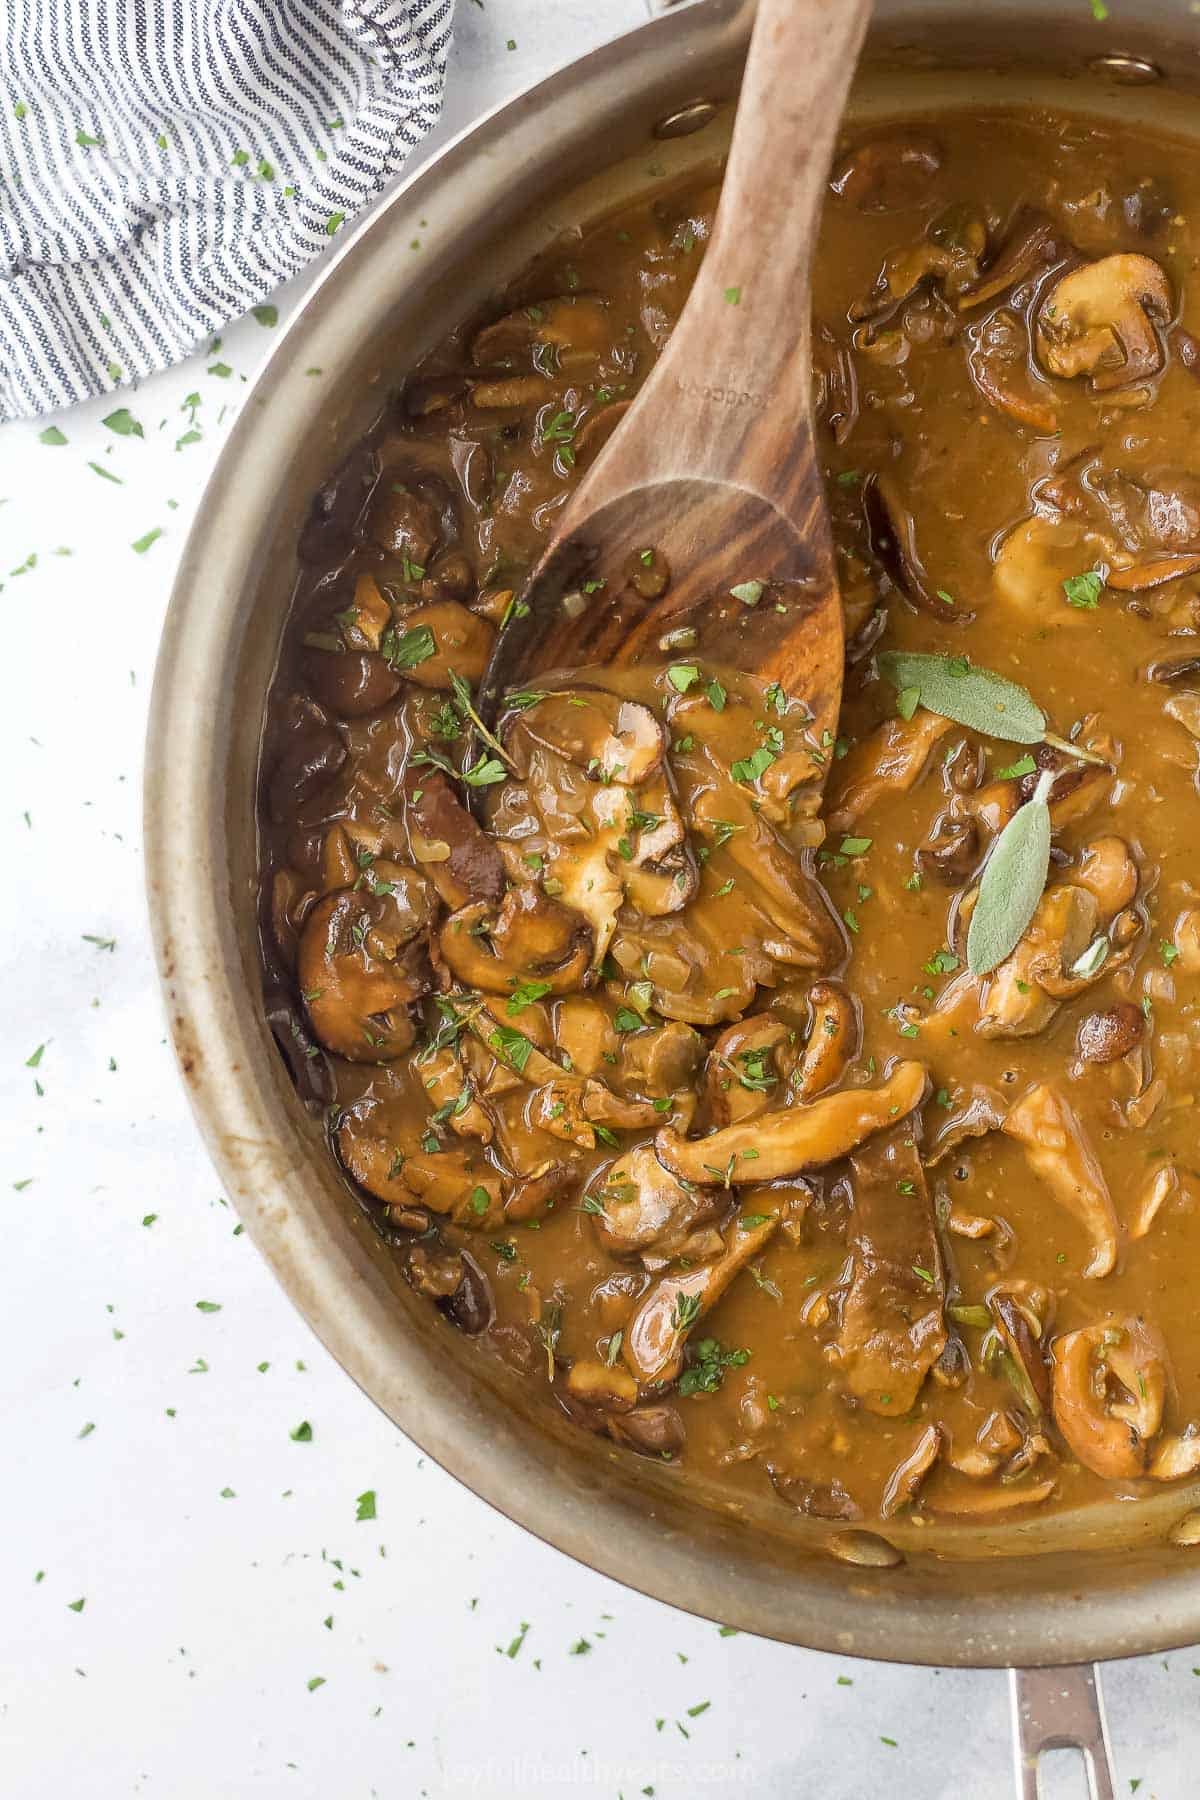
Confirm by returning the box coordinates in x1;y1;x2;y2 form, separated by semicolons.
0;0;453;421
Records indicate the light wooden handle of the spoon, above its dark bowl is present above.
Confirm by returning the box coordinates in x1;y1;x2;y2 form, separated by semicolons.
575;0;871;522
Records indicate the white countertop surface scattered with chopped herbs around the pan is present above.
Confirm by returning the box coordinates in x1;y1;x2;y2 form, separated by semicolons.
0;0;1200;1800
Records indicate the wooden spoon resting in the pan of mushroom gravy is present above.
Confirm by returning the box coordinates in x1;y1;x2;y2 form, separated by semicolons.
479;0;871;742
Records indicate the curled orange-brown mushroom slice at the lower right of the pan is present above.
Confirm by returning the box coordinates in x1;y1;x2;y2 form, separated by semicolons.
1054;1318;1169;1481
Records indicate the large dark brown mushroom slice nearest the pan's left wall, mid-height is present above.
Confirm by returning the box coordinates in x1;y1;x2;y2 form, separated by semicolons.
297;862;432;1062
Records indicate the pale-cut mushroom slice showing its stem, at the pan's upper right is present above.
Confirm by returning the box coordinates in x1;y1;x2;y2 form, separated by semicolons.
1036;252;1175;394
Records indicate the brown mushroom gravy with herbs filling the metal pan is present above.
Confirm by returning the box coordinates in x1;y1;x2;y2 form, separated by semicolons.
261;110;1200;1521
